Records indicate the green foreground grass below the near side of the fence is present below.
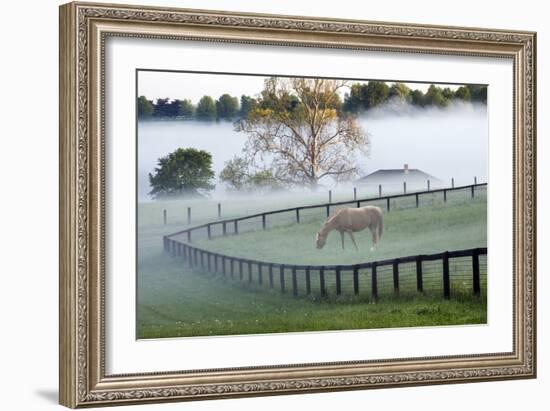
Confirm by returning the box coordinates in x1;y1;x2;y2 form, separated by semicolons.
138;255;487;338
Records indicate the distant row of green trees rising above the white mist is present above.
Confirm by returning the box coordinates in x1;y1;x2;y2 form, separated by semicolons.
137;81;487;121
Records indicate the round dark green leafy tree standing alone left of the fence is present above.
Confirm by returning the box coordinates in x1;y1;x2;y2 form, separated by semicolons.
149;148;214;198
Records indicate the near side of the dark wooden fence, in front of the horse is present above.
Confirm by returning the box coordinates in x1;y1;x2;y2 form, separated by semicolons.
164;237;487;301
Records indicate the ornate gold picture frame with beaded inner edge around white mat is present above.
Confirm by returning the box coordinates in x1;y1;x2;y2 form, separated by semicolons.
59;3;536;408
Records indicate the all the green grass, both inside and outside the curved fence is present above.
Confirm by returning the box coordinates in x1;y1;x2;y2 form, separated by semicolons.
138;190;487;338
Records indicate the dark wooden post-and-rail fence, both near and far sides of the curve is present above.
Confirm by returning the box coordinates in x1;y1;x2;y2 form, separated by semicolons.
163;183;487;301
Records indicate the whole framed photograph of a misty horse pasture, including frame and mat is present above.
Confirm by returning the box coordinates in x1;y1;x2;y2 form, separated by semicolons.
60;3;536;408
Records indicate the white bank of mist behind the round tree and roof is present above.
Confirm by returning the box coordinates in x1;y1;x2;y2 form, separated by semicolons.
137;101;488;201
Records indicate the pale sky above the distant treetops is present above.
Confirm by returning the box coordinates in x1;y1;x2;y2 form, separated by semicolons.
138;71;466;104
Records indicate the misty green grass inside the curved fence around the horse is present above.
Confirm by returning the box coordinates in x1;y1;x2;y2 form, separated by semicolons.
194;198;487;264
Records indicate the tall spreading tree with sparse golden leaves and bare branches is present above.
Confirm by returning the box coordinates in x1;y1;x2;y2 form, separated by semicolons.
236;78;368;189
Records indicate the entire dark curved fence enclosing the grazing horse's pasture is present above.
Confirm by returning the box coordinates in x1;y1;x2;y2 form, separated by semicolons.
163;183;487;301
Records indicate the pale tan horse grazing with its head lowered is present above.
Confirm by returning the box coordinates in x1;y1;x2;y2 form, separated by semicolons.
317;206;384;251
